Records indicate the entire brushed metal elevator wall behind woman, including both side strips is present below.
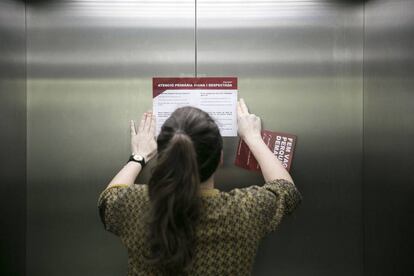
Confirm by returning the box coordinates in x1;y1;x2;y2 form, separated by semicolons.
0;0;414;276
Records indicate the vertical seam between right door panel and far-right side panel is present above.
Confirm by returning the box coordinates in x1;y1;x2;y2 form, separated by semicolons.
361;1;366;275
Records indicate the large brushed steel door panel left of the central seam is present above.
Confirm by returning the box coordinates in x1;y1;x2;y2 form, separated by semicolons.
27;1;194;276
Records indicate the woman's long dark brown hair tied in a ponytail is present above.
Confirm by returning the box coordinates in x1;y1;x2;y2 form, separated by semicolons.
147;107;223;275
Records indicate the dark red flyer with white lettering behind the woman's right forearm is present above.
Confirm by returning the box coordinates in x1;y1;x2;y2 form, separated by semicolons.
234;130;296;171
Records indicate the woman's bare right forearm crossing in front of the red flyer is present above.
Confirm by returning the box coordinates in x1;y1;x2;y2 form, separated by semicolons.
245;137;293;183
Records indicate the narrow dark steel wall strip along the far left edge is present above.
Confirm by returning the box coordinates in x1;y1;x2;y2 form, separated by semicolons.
0;0;26;275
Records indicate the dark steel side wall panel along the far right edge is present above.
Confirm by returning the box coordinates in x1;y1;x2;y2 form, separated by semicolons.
364;0;414;276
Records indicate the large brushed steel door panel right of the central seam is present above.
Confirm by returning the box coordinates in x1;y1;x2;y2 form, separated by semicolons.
197;0;363;276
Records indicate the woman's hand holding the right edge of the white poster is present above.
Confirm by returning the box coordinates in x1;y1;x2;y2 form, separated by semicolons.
237;99;262;143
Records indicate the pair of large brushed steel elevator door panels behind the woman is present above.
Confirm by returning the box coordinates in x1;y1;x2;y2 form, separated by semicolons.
27;0;363;275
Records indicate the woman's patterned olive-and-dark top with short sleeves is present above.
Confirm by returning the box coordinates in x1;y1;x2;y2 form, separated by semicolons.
98;179;302;276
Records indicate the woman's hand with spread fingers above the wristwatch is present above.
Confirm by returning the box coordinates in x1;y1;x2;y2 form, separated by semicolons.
130;112;157;162
